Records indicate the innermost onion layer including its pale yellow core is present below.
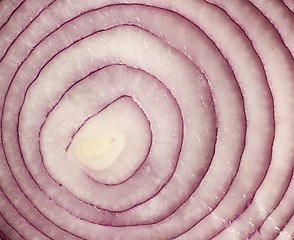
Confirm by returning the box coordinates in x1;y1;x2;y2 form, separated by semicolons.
67;96;151;184
